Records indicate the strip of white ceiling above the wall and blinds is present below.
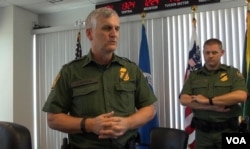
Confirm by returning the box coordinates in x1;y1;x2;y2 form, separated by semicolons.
0;0;118;14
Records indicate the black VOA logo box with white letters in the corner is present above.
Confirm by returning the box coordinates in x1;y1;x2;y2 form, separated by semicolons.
222;133;250;149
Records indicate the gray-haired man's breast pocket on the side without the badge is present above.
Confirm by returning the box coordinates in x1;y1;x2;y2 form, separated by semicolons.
72;83;102;116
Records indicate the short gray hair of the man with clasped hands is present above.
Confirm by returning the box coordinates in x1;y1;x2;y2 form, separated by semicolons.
85;7;118;28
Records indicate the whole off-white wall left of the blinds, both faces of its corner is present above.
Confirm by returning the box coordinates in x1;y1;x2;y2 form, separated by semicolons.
0;6;38;148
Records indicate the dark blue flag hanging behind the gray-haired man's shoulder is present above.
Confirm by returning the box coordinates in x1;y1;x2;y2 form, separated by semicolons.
138;24;159;149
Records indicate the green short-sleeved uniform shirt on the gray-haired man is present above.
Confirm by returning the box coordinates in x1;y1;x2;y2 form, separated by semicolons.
43;52;157;149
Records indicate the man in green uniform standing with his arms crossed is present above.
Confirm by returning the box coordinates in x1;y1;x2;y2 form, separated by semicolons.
180;38;247;149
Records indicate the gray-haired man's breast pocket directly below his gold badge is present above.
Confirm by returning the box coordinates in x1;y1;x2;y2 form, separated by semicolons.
115;81;136;113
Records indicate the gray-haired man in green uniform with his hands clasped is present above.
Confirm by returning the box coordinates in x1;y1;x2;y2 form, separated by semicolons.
43;8;157;149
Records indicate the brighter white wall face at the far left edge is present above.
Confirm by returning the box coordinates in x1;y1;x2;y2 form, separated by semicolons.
0;8;13;121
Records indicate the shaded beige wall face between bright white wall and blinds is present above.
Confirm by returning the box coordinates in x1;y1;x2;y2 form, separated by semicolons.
13;7;38;148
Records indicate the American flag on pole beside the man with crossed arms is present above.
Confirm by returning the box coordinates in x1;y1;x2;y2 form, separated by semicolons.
185;18;202;149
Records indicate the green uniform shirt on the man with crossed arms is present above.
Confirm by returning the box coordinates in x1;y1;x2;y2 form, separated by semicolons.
181;64;247;122
